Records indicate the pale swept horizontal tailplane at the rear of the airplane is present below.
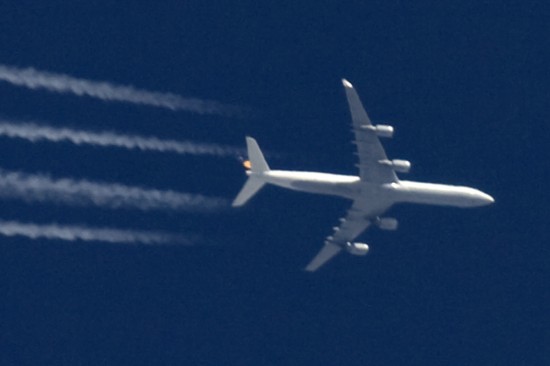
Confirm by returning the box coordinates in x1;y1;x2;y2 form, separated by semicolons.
232;137;269;207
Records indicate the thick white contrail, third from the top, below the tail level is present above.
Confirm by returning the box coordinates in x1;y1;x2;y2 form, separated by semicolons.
0;169;227;212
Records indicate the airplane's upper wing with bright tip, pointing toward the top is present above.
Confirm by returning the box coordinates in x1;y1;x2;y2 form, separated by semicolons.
342;79;397;183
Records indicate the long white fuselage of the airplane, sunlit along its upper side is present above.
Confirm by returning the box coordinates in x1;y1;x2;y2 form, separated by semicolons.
247;170;494;208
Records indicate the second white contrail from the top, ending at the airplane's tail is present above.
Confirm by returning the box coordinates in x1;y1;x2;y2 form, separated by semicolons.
0;119;244;156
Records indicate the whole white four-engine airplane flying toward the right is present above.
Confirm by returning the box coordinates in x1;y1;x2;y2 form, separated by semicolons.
232;79;494;272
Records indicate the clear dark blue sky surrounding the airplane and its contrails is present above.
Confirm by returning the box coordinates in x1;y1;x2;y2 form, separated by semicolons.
0;1;550;365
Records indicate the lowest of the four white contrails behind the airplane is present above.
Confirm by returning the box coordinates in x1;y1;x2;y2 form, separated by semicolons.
0;220;193;245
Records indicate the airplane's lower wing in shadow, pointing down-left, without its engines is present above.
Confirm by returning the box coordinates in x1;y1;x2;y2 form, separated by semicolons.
305;200;372;272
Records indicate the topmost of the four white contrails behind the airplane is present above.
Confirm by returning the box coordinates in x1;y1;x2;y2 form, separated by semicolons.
0;65;243;115
